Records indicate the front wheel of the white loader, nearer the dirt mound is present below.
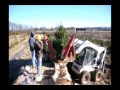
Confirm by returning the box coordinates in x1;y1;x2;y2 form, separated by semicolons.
79;71;91;85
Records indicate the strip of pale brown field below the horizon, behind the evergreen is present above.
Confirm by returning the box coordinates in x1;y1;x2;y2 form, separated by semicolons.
36;30;111;39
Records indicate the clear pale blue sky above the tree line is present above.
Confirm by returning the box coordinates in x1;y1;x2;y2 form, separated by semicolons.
9;5;111;28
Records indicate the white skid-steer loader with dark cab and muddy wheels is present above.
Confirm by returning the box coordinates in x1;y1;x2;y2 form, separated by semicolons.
71;38;106;85
